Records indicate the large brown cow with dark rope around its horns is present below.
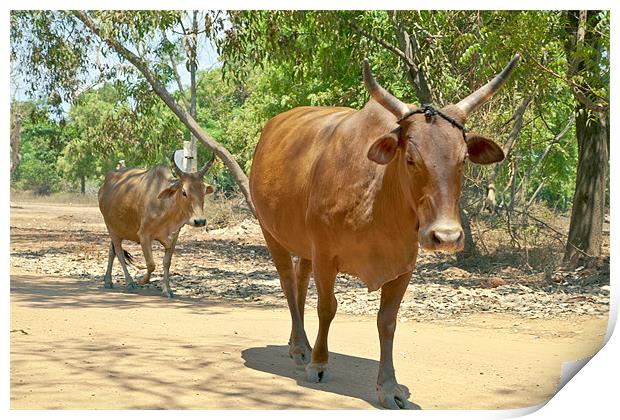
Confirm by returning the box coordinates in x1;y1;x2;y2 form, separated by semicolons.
250;56;518;408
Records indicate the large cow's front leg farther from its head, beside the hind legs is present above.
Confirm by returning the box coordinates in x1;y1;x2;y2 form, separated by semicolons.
306;255;338;382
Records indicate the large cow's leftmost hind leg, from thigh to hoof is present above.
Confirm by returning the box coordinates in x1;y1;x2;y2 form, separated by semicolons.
263;225;312;366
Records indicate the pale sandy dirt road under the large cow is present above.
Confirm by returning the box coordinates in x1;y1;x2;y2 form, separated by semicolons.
10;205;607;409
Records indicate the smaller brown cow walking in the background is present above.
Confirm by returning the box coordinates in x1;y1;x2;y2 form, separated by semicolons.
99;156;213;298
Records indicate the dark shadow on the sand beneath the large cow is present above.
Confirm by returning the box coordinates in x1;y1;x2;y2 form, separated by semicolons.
241;345;421;410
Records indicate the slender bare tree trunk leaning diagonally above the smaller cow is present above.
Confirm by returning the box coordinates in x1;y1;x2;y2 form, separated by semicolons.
73;10;256;216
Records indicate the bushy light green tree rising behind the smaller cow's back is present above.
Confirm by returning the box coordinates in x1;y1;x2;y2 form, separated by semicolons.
58;82;182;192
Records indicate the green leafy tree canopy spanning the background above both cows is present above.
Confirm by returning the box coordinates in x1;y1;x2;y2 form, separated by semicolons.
11;10;610;208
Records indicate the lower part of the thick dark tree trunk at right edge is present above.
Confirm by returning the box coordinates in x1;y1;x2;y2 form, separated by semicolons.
564;106;609;267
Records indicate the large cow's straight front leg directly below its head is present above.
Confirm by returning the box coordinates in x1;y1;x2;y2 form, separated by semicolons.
377;272;411;409
